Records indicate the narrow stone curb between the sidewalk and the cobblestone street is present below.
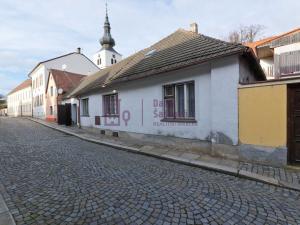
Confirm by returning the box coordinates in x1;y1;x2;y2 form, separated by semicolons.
26;118;300;192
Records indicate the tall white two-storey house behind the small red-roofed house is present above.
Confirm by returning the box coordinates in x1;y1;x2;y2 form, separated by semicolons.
29;48;99;119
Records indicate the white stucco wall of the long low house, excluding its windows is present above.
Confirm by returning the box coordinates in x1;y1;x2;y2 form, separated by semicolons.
81;57;240;145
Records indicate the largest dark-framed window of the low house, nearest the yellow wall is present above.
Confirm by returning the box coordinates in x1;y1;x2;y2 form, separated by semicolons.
164;82;195;119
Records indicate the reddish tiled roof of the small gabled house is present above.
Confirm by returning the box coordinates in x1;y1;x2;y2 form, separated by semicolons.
46;69;86;93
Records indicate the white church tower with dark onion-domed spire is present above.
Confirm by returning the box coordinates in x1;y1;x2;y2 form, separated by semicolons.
93;4;122;69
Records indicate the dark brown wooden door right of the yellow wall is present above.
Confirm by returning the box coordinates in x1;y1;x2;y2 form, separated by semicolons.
287;84;300;164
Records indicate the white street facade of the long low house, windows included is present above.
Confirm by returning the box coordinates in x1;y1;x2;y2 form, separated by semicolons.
80;56;255;145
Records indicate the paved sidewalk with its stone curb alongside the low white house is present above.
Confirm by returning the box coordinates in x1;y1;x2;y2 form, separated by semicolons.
28;118;300;191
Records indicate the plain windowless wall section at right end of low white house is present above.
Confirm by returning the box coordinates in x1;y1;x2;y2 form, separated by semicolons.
210;57;239;145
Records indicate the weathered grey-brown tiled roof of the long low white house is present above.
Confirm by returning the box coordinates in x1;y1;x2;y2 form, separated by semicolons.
69;28;260;96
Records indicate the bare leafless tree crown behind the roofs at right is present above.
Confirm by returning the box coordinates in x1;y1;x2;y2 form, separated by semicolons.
227;24;265;43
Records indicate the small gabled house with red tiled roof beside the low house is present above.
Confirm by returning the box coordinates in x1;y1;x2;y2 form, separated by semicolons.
45;69;85;124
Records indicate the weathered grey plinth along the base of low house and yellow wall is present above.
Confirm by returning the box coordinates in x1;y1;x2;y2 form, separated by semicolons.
83;127;287;166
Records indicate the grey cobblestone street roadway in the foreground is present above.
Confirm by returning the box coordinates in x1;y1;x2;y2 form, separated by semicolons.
0;118;300;225
